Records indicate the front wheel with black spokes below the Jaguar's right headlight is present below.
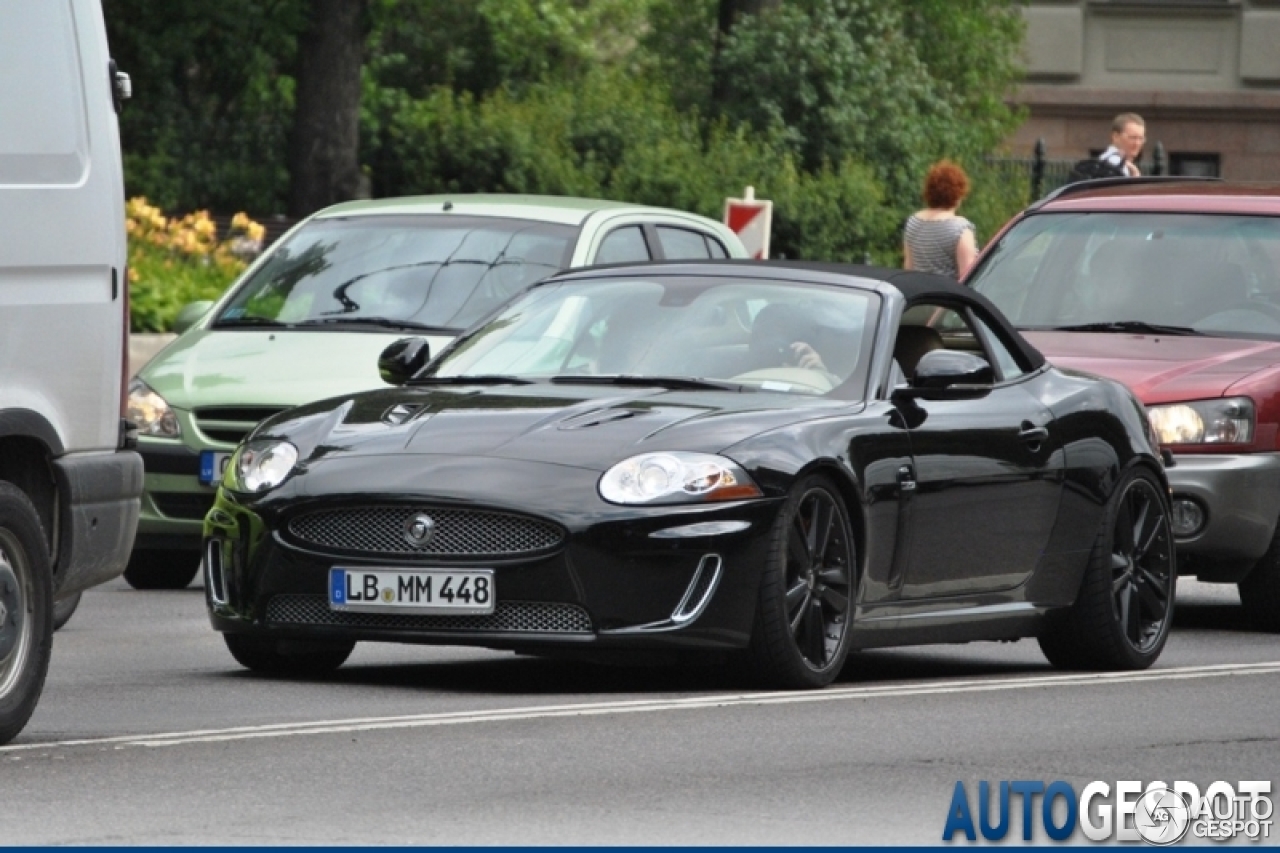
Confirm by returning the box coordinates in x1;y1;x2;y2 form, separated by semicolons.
749;474;858;689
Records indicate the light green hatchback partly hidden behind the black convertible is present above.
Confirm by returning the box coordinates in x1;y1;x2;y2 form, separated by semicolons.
124;195;746;589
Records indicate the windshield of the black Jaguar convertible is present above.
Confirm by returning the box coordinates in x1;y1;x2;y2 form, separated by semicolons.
422;275;879;397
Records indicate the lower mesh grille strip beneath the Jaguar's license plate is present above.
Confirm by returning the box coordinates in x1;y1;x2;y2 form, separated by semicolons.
266;596;591;634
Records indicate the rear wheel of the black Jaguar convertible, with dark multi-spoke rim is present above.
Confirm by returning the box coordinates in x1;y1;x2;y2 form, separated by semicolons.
1039;469;1178;670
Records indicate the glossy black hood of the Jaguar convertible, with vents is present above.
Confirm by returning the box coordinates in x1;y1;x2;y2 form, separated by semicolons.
253;383;861;470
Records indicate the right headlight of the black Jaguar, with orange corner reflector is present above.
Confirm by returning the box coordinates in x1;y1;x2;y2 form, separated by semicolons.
600;451;762;503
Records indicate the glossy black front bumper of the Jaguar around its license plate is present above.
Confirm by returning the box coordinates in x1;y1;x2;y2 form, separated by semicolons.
204;469;782;649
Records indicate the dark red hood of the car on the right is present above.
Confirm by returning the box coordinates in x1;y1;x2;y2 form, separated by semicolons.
1023;332;1280;405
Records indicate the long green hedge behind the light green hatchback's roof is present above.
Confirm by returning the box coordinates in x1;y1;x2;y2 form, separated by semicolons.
371;72;901;263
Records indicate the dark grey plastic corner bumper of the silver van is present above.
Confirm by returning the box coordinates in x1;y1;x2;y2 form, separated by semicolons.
54;451;142;598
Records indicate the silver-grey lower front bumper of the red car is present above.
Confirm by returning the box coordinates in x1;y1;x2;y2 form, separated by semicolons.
1167;453;1280;562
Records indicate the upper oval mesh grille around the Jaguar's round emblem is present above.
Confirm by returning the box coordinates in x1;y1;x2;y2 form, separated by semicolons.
288;506;564;557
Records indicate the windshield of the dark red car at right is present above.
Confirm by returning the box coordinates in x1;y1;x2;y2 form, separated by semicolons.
969;213;1280;338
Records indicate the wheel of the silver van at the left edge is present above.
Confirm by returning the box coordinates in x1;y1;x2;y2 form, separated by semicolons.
0;482;54;744
